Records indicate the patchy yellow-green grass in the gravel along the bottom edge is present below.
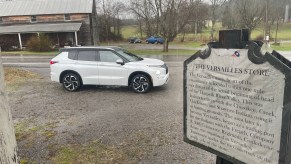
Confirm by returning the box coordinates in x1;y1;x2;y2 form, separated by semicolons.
51;131;169;164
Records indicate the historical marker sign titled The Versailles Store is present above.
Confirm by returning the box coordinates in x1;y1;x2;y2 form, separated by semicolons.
184;33;291;164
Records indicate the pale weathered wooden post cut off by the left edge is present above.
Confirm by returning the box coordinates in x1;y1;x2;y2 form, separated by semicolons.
0;58;18;164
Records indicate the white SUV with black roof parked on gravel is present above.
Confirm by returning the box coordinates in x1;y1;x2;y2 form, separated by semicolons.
50;47;169;93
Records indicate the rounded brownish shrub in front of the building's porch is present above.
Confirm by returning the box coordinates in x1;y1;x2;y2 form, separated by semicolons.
27;34;52;52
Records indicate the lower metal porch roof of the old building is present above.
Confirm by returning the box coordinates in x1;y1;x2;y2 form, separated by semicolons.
0;23;82;34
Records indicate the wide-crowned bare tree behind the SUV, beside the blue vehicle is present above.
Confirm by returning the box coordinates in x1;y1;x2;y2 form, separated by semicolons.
130;0;194;52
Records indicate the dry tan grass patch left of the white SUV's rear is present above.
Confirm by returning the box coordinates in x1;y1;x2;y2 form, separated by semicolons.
4;67;38;92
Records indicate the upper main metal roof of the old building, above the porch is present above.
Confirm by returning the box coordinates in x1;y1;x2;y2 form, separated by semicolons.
0;0;93;17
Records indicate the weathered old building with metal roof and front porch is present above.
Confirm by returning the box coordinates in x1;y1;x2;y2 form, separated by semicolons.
0;0;94;49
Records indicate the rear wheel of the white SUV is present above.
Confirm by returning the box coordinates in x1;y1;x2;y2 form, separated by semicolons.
62;73;81;92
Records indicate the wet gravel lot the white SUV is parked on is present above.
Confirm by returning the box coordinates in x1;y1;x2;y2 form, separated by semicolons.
9;67;216;164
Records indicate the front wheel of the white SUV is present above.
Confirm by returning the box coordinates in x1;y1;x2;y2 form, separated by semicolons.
130;74;151;93
